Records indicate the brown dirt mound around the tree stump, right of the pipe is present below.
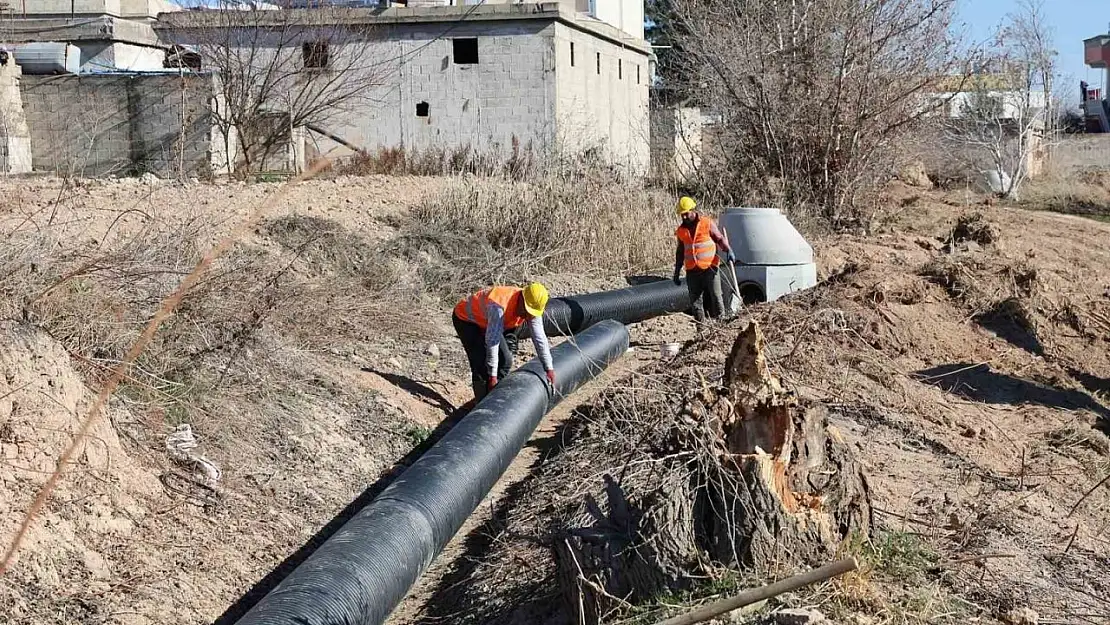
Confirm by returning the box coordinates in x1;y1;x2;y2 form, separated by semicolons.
412;209;1110;624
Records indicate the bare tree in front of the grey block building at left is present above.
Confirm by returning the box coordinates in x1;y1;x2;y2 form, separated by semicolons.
161;1;391;174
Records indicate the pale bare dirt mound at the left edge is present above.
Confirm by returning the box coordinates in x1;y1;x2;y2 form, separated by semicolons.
0;322;164;623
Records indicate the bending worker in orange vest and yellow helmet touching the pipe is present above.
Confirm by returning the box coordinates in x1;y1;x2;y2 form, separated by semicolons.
453;282;555;402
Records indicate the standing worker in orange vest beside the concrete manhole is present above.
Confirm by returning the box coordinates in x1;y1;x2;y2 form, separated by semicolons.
675;196;736;322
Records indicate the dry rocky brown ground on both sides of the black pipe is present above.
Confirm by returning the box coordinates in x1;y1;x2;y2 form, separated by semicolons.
0;177;1110;624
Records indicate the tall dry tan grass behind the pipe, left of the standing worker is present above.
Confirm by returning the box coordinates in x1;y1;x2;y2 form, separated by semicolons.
400;171;674;300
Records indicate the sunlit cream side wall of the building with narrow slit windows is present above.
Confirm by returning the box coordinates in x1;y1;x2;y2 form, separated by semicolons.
554;23;650;175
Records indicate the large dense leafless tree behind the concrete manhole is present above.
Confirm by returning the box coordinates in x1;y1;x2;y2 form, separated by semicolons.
667;0;966;224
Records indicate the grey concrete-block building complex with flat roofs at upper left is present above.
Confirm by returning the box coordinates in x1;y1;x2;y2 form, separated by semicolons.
0;0;653;175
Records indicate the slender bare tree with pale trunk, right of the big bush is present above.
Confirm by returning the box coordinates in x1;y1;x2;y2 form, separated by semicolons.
948;0;1057;198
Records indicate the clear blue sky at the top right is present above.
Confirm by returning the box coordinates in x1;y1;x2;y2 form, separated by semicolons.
959;0;1110;105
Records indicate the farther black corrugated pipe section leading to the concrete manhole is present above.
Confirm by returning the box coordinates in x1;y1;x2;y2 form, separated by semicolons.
539;280;690;336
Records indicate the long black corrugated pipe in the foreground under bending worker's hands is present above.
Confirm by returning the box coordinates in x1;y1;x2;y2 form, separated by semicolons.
236;321;628;625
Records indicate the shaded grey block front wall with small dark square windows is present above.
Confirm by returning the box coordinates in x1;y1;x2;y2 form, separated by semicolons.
314;22;555;164
